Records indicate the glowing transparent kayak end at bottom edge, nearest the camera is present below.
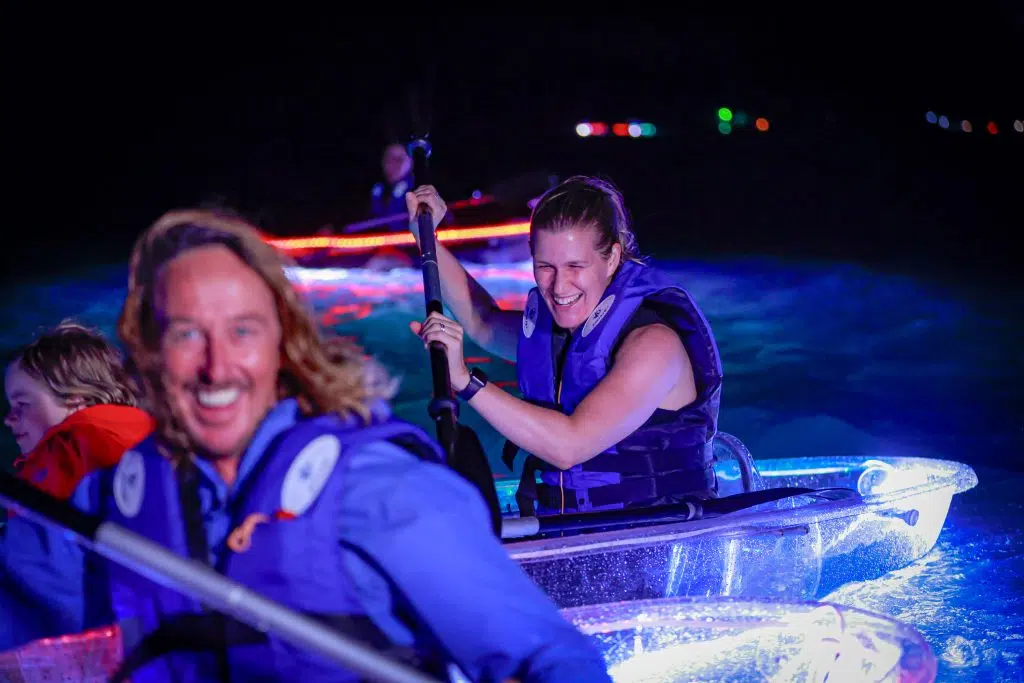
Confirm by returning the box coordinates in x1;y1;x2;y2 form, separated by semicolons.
562;598;937;683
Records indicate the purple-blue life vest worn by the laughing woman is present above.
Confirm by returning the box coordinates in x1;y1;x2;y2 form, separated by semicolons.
504;261;722;516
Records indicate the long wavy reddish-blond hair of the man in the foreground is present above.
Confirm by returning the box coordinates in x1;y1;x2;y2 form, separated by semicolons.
118;210;395;460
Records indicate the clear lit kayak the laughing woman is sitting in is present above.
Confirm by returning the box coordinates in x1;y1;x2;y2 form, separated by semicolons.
499;434;978;607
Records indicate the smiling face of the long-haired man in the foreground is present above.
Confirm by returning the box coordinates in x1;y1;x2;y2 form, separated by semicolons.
154;245;283;484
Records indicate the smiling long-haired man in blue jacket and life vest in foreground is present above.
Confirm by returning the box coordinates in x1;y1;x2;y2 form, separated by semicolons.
75;212;608;682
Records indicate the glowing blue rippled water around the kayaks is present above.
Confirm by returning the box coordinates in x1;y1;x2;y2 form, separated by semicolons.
0;260;1024;680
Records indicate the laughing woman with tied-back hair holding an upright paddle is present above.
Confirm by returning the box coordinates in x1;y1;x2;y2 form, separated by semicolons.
406;176;722;516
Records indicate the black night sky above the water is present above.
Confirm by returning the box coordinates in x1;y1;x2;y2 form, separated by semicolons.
4;7;1024;284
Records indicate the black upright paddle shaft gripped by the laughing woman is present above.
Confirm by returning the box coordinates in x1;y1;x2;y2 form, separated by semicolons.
409;137;459;459
